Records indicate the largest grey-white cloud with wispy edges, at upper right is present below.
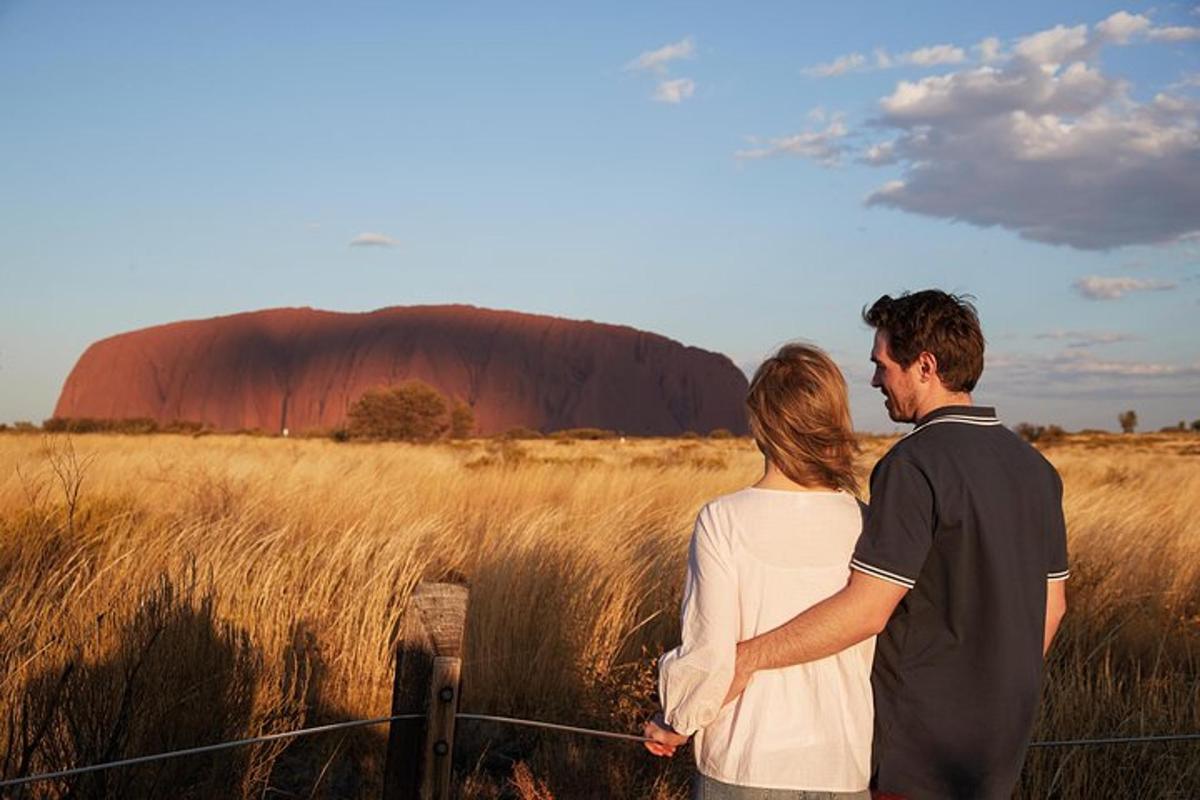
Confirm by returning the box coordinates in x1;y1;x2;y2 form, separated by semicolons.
737;11;1200;249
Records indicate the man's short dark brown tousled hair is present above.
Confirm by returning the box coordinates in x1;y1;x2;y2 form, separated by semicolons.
863;289;984;392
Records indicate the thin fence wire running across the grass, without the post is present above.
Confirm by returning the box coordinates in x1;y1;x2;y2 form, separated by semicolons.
0;714;1200;789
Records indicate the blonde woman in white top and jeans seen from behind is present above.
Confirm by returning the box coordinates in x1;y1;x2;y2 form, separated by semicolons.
646;344;875;800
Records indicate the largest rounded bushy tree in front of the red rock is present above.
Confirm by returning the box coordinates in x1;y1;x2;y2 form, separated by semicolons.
347;380;449;441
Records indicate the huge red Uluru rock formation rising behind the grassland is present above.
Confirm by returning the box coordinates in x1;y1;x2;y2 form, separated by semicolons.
54;306;746;435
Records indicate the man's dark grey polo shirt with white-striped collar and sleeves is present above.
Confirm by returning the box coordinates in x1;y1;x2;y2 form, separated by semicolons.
851;405;1068;800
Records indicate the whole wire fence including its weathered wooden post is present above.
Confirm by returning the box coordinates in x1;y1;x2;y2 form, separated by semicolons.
0;584;1200;800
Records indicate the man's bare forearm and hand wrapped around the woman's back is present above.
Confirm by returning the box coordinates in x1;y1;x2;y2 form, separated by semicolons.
725;570;908;703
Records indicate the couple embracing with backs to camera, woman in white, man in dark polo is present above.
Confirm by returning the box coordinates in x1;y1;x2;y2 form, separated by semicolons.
646;290;1068;800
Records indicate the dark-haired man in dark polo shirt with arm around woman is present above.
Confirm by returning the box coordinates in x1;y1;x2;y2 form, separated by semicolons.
661;290;1068;800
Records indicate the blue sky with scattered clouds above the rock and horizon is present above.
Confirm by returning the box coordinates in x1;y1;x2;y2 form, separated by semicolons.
0;0;1200;431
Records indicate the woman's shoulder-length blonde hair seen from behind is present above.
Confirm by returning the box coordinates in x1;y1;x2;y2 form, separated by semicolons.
746;343;858;494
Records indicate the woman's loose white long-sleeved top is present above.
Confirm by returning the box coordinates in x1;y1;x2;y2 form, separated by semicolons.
659;488;875;792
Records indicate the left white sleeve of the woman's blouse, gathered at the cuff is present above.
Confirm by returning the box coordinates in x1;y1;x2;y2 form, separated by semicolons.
659;506;739;736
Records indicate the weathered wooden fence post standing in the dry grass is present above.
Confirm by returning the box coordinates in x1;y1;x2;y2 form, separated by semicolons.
383;583;469;800
